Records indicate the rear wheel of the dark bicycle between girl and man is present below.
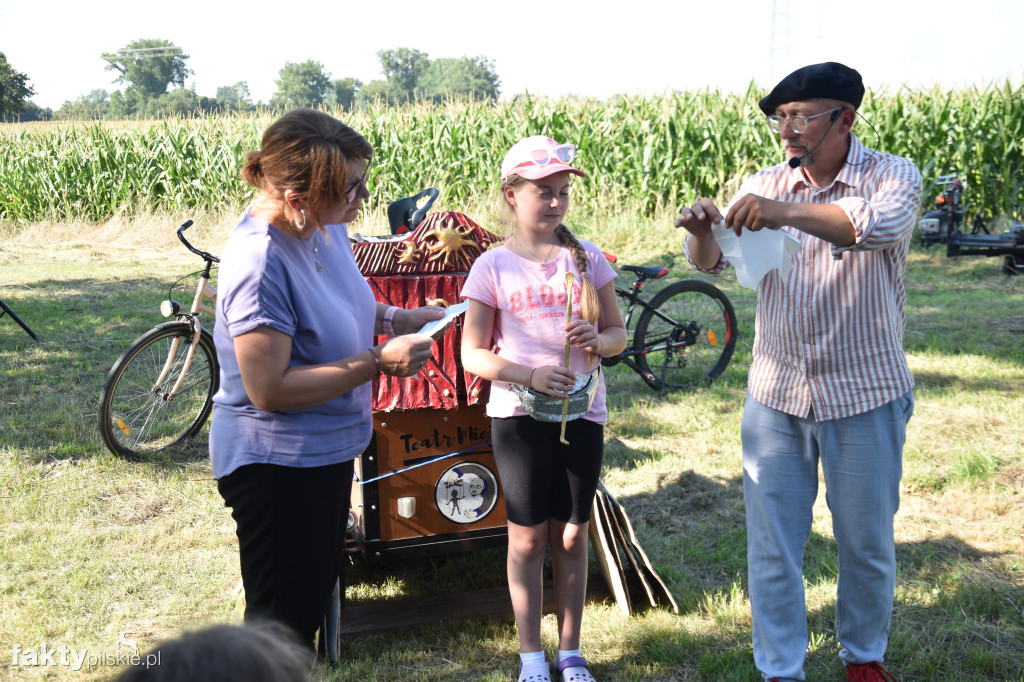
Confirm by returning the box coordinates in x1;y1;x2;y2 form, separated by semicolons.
633;280;736;390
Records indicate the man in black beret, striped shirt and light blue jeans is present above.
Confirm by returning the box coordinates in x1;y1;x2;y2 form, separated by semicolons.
676;61;921;682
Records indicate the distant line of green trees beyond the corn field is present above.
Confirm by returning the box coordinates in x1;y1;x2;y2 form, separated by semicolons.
0;39;501;121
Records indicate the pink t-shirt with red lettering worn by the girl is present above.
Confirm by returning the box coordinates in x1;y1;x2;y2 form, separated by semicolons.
462;241;615;424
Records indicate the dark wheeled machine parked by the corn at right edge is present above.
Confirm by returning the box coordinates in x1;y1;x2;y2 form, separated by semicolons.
918;174;1024;274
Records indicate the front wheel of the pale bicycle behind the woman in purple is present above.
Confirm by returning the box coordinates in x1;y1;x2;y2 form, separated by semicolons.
99;322;219;458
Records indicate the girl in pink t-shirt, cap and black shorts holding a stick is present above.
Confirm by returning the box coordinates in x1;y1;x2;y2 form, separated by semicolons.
462;135;626;682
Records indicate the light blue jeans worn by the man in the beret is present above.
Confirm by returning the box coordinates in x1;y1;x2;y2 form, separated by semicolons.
742;392;913;680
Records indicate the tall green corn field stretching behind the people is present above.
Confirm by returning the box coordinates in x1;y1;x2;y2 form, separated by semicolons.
0;82;1024;225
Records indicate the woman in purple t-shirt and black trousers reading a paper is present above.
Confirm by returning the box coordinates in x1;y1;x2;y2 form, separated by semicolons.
210;109;441;646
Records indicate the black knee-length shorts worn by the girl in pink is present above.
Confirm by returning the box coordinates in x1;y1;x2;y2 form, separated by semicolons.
490;417;604;525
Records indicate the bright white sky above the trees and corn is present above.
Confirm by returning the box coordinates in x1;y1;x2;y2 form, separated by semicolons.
0;0;1024;110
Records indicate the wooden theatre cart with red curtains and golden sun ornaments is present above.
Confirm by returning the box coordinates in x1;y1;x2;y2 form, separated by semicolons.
348;212;507;565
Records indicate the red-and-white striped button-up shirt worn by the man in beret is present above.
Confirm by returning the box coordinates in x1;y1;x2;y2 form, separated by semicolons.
690;134;922;422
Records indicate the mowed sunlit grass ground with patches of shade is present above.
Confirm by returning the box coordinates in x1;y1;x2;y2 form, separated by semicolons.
0;205;1024;682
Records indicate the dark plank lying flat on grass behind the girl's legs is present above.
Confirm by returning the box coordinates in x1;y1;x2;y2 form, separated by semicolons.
340;580;609;637
